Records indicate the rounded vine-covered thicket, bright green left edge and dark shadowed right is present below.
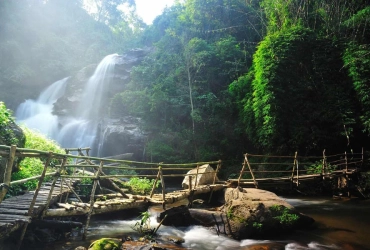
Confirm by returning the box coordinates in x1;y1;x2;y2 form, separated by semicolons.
237;26;355;153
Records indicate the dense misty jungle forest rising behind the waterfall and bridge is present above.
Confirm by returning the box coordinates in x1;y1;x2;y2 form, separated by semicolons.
0;0;370;168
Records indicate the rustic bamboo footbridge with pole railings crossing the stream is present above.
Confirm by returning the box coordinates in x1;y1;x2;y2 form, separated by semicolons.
0;145;365;249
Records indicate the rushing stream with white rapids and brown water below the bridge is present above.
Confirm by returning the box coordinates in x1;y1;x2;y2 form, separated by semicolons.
33;197;370;250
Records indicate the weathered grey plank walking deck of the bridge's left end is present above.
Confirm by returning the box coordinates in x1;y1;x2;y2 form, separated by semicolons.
0;182;73;239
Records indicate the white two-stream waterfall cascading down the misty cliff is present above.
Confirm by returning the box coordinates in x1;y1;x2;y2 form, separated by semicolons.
16;54;118;148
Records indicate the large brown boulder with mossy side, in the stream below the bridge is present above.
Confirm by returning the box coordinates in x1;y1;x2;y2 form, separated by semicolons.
219;188;314;239
